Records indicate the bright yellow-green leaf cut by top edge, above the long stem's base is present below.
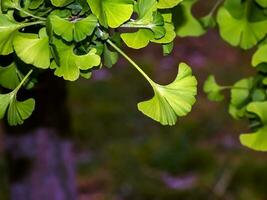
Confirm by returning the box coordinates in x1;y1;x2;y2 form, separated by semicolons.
87;0;133;28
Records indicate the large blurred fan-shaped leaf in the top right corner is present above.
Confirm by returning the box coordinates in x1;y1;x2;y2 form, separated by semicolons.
217;0;267;49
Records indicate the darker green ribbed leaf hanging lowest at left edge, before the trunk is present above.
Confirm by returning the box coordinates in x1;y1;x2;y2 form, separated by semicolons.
0;91;35;126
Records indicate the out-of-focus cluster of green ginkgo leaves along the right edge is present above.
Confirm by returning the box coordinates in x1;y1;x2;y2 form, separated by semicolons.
204;0;267;151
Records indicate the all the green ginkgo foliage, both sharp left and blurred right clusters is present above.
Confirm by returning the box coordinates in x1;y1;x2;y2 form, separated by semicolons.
0;0;267;151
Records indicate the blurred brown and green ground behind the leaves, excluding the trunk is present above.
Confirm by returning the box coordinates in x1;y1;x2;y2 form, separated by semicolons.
0;1;267;200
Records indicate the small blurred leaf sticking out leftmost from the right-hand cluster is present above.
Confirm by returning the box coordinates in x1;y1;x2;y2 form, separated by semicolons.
203;75;224;101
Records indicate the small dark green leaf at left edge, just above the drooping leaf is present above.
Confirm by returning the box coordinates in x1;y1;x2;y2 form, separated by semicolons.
0;62;20;90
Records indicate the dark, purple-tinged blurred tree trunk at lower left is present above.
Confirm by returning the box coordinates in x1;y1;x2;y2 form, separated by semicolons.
5;74;77;200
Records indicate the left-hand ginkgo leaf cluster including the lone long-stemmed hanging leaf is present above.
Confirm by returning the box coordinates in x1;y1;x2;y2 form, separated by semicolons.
0;0;204;125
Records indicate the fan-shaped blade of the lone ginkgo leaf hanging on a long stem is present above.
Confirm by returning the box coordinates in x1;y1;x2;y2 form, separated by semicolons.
138;63;197;125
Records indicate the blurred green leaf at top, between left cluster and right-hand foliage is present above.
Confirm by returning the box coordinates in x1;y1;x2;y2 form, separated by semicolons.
173;0;206;37
